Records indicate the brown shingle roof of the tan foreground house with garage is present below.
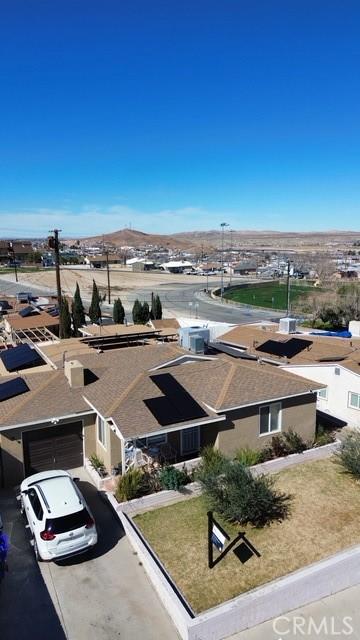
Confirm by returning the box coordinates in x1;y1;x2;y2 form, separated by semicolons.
0;344;322;438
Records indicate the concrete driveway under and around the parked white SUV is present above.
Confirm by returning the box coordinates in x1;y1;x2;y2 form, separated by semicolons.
0;481;178;640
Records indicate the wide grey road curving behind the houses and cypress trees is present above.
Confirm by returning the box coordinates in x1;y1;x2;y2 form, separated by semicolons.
0;276;283;324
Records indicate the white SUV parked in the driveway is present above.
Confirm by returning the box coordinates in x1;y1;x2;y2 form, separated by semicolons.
19;471;97;560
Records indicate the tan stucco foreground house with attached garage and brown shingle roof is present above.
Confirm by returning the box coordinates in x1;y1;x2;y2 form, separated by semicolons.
0;339;322;485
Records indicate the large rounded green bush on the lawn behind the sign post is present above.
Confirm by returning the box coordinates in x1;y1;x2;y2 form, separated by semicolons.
202;461;291;527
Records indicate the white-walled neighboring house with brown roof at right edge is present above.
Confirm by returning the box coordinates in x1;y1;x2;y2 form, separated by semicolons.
219;325;360;427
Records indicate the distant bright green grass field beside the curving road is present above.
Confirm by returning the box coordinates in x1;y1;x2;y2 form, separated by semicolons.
224;282;319;309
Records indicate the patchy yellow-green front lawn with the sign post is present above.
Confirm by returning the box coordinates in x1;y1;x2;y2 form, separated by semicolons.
134;459;360;613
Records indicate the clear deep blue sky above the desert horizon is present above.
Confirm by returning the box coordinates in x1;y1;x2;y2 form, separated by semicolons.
0;0;360;236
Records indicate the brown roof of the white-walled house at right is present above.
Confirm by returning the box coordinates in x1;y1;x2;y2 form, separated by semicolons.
219;325;360;364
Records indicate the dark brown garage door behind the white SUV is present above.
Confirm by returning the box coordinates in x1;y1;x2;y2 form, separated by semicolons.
23;422;83;476
